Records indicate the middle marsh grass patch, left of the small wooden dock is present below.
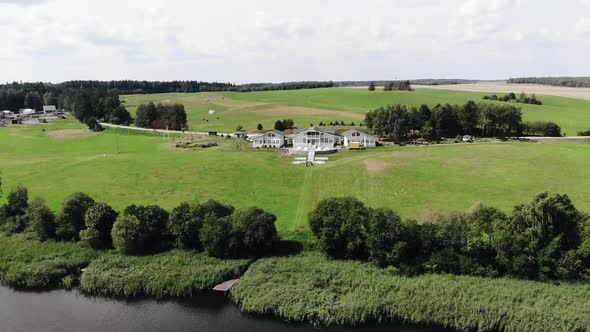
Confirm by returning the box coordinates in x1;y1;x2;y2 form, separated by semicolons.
80;250;250;298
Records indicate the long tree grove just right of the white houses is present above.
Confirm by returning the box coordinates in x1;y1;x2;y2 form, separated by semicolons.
364;101;523;142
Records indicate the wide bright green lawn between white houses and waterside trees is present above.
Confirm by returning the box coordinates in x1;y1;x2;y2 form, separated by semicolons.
0;121;590;234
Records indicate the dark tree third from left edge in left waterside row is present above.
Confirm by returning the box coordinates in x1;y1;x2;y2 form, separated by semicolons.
55;192;94;241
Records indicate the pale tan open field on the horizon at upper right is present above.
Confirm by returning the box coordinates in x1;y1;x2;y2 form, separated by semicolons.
413;82;590;100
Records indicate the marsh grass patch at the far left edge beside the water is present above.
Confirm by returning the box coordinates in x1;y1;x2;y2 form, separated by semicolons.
0;234;100;288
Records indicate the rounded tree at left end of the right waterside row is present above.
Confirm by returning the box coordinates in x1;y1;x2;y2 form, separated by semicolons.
309;197;369;259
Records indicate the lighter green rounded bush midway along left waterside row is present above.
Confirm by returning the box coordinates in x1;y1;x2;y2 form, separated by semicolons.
111;214;142;255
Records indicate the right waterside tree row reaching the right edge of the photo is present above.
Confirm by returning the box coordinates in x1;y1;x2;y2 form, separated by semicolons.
309;193;590;280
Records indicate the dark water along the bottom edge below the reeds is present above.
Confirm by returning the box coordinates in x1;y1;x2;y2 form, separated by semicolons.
0;287;440;332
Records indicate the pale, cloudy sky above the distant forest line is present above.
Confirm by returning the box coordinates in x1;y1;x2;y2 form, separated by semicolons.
0;0;590;84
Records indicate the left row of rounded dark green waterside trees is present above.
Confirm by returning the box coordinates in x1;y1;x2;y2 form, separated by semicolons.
0;187;279;258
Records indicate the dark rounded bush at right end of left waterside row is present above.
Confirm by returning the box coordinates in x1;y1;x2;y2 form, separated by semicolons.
232;208;278;256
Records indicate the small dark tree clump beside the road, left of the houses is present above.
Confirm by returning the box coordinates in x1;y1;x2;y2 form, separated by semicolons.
135;102;186;130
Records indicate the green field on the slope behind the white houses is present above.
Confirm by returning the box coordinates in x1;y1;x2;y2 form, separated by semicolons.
123;88;590;136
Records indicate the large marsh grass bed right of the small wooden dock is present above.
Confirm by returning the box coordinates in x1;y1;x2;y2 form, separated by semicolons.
232;252;590;331
